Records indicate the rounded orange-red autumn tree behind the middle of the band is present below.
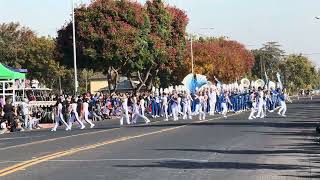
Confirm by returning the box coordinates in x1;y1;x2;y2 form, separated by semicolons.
179;38;254;83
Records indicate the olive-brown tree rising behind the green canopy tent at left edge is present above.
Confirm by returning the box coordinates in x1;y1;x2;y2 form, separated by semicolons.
0;23;64;88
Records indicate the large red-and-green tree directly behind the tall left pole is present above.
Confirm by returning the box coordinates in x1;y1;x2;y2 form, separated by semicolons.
57;0;153;90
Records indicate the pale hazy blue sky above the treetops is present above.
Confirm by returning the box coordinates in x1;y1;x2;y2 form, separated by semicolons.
0;0;320;66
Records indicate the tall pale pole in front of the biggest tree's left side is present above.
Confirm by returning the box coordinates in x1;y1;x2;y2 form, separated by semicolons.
71;0;78;95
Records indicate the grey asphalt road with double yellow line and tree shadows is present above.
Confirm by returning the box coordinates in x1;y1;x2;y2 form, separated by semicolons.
0;98;320;180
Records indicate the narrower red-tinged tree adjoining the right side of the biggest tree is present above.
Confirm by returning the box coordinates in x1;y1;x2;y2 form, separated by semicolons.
144;0;188;87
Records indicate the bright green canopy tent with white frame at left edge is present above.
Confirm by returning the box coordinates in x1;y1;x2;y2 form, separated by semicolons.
0;63;26;102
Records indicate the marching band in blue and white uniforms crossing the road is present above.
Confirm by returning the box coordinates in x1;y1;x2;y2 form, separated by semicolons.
46;76;290;131
